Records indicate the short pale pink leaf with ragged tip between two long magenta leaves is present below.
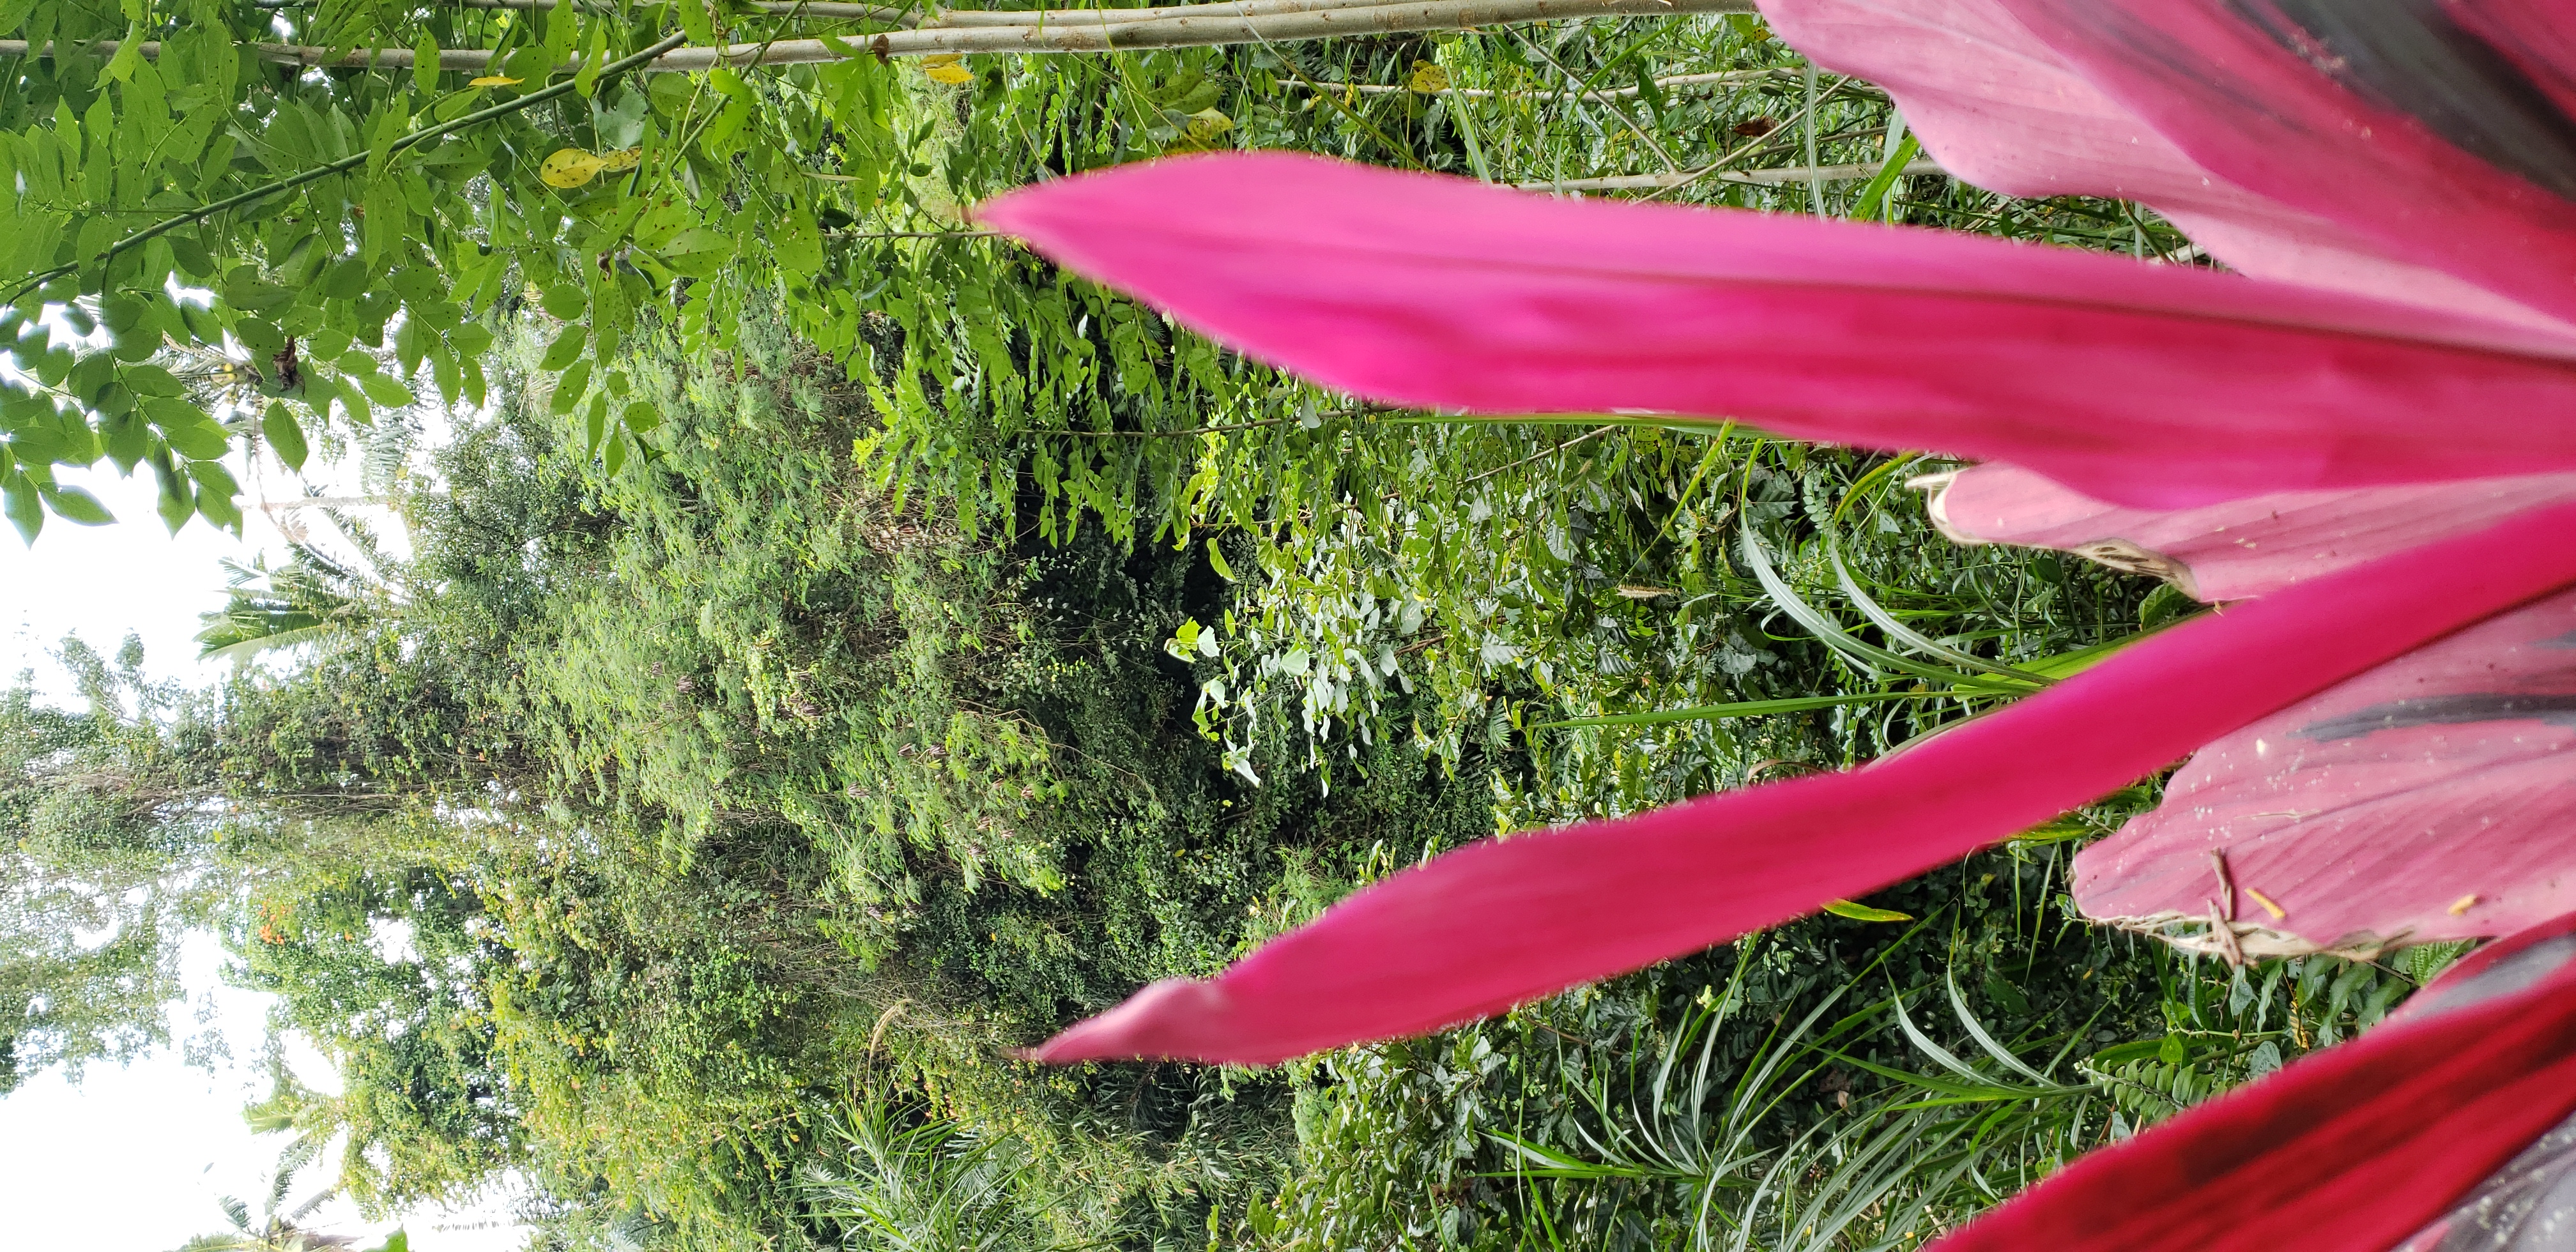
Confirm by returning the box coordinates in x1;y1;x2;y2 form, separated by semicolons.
1929;464;2576;603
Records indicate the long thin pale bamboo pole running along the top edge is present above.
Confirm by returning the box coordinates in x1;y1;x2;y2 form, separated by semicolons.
0;0;1754;75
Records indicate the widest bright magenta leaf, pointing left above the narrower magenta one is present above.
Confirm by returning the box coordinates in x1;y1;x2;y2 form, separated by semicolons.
979;155;2576;507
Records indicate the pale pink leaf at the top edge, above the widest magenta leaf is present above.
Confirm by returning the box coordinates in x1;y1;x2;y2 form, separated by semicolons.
1762;0;2576;332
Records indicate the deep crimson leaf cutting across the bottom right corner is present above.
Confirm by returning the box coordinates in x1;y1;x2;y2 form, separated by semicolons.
1932;912;2576;1252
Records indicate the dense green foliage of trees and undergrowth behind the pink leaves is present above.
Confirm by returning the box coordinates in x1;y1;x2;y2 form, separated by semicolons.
0;0;2450;1252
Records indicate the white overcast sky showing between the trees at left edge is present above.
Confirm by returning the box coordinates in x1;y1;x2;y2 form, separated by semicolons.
0;445;526;1252
